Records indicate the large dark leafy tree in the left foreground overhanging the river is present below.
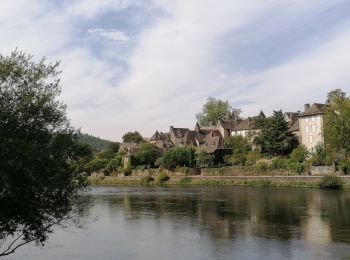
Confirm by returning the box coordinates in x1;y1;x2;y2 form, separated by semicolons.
0;50;87;257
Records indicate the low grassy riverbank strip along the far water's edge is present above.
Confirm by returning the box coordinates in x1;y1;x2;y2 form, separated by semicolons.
88;176;350;189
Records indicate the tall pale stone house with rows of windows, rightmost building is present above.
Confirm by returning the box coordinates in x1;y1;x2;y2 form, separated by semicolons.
298;103;325;151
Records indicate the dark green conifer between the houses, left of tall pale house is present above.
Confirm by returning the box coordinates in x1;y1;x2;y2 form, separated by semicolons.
253;110;298;155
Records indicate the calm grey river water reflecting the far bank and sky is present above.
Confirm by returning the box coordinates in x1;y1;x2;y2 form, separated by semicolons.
7;187;350;260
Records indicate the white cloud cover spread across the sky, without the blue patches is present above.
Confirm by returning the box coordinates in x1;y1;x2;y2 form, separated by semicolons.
0;0;350;140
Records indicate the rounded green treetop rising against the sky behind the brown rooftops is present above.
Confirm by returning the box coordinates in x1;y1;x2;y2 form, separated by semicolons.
196;97;242;126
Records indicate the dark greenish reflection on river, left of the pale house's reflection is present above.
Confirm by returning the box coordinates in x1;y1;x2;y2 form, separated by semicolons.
105;188;307;240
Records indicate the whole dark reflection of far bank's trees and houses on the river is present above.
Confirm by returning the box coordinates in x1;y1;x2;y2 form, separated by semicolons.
100;187;350;242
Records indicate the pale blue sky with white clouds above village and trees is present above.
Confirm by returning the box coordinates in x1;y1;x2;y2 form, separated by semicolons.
0;0;350;141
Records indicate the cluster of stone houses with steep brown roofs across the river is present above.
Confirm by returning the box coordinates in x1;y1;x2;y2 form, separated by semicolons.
145;103;325;154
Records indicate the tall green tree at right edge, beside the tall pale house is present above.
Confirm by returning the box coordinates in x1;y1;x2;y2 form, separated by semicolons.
324;89;350;159
